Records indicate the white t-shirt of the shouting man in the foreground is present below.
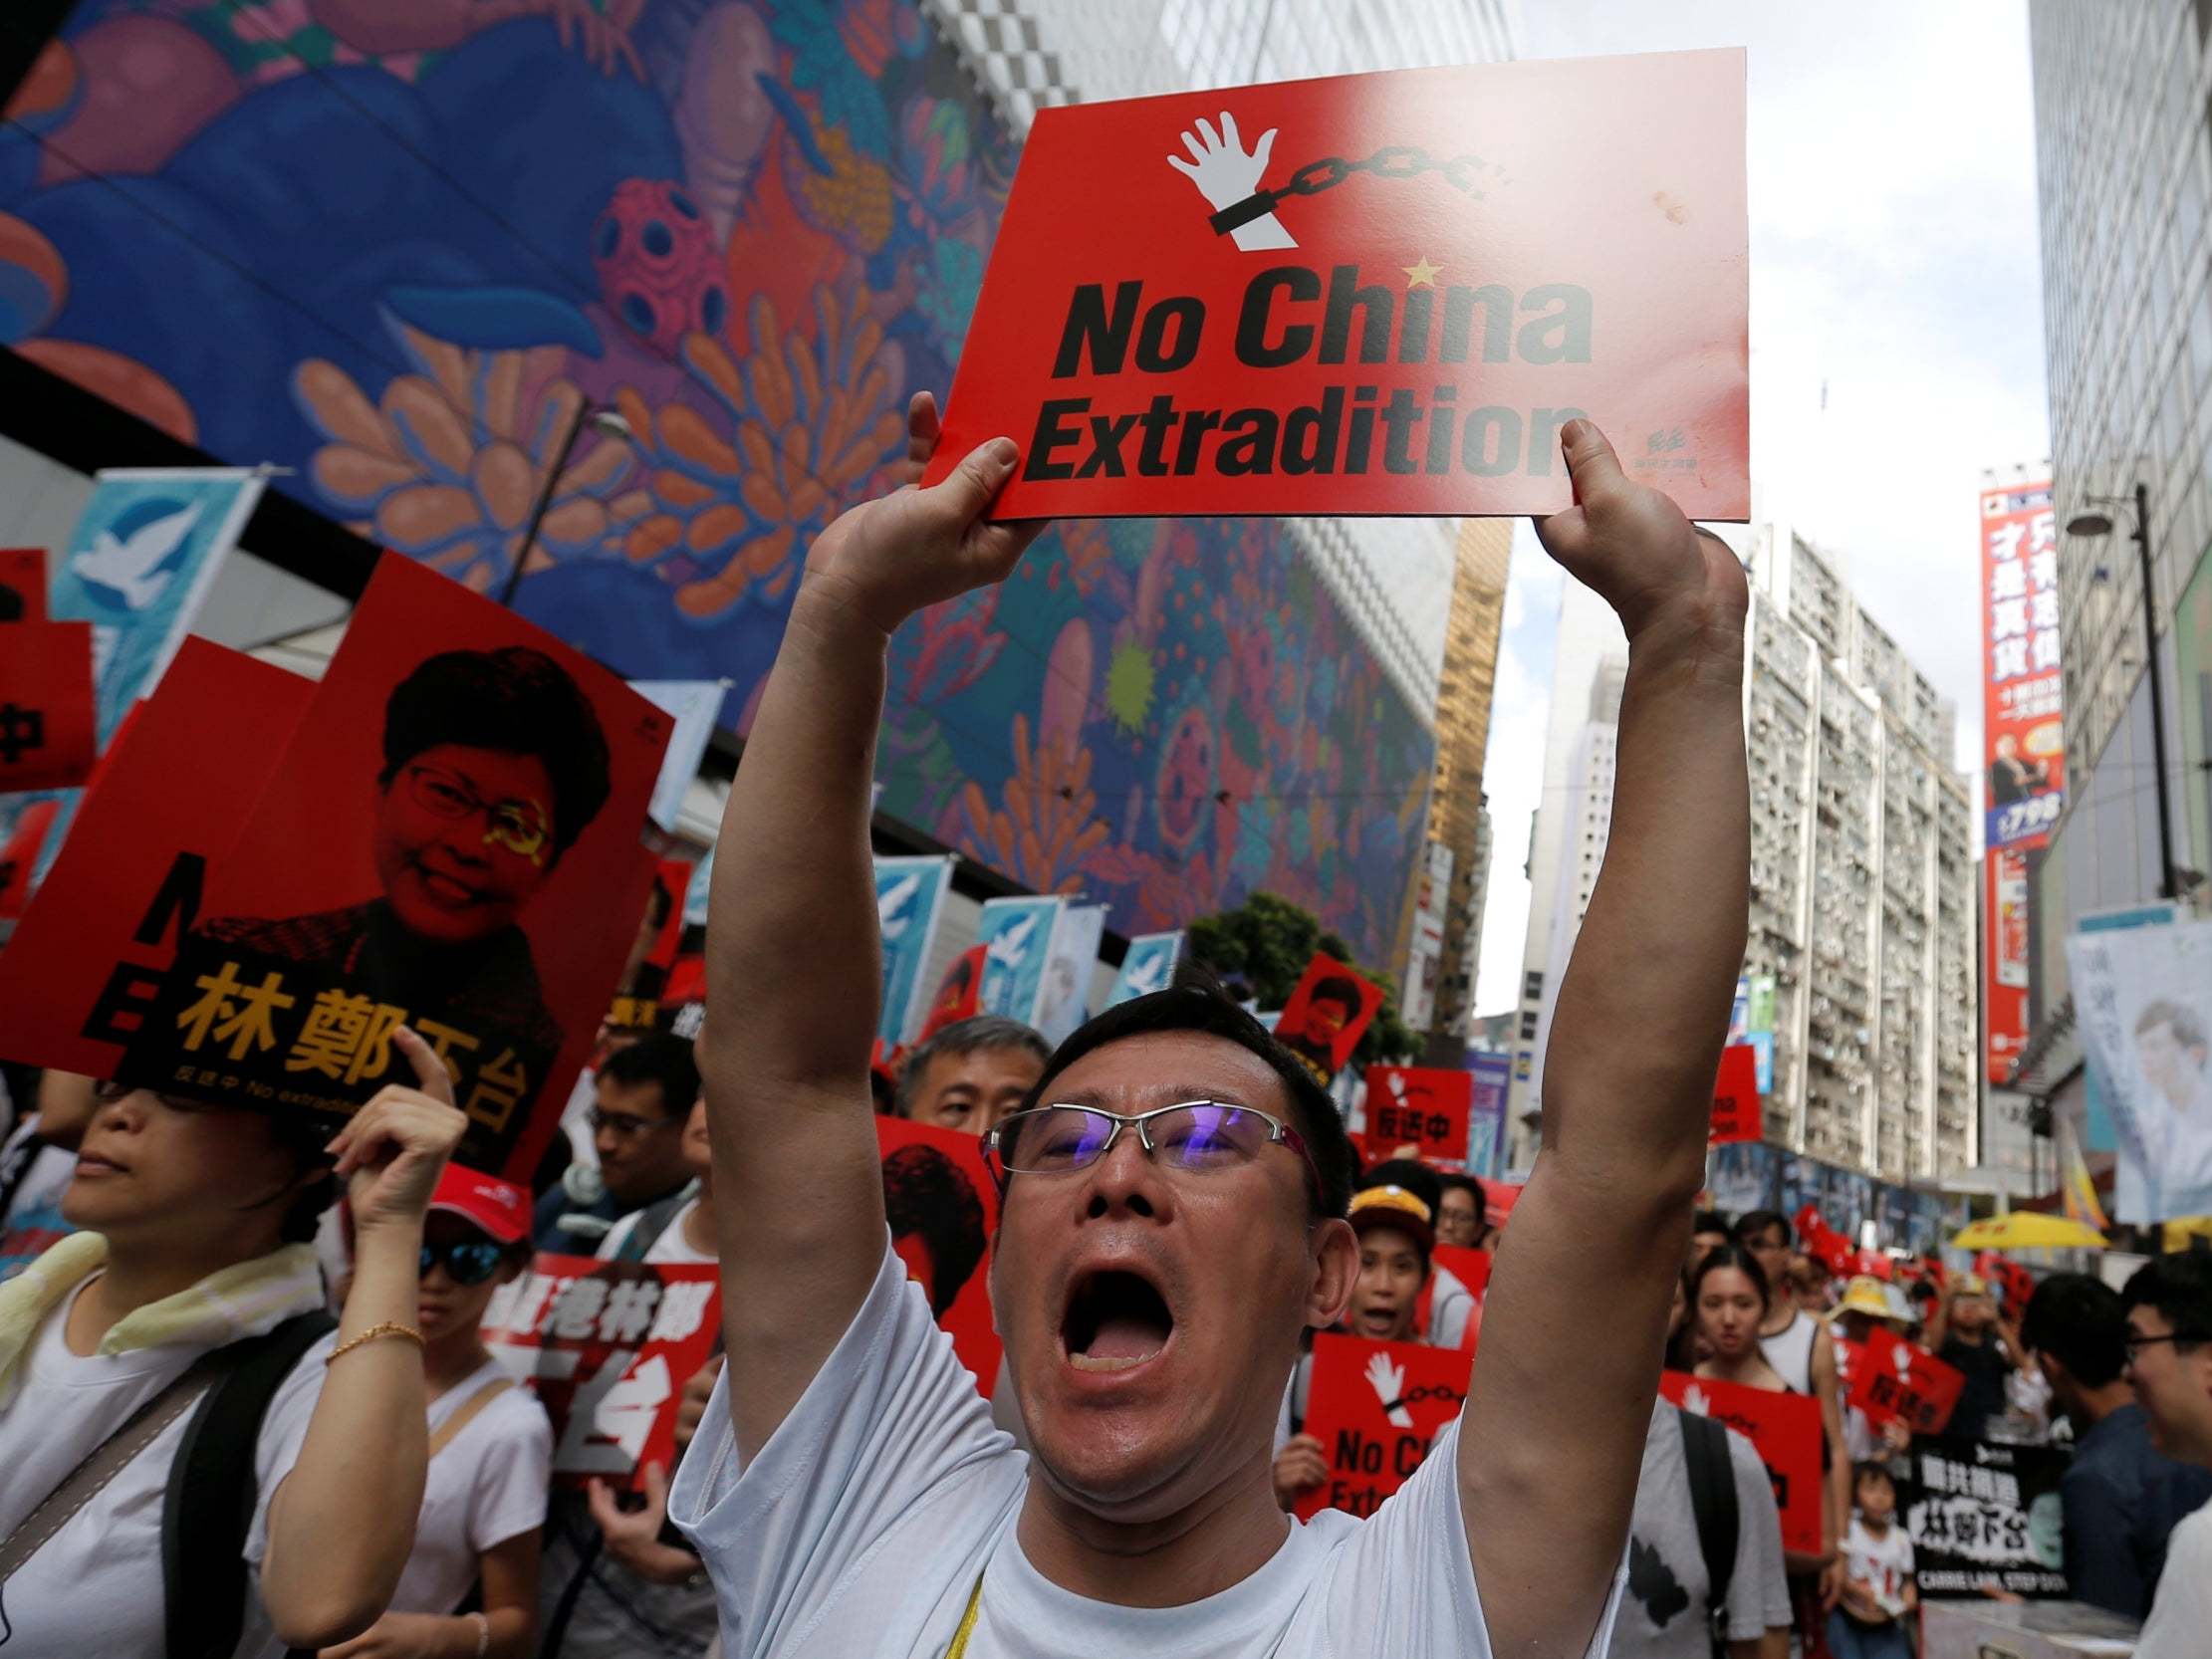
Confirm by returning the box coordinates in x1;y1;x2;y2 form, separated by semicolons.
668;1248;1619;1659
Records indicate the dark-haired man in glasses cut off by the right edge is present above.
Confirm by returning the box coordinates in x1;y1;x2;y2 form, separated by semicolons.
2119;1250;2212;1659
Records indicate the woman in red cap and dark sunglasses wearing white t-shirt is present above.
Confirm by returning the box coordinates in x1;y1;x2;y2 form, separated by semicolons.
321;1163;553;1659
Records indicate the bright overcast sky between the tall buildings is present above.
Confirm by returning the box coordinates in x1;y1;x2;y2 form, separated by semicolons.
1475;0;2049;1013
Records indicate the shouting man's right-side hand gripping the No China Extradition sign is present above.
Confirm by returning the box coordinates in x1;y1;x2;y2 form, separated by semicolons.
1535;420;1752;663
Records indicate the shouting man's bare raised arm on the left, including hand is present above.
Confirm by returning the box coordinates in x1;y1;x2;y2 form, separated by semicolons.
699;393;1038;1458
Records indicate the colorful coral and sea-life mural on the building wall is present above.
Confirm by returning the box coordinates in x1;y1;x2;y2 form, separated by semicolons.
0;0;1431;960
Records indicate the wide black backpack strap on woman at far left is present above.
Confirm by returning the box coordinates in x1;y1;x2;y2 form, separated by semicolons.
161;1309;339;1659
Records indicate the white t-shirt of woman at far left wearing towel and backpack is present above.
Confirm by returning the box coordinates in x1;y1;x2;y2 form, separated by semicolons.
0;1277;332;1659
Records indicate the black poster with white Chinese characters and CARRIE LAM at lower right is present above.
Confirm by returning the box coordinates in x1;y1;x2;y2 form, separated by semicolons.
1898;1440;2069;1601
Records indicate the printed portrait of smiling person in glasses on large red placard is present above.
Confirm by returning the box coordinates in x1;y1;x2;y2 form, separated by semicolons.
201;646;611;1070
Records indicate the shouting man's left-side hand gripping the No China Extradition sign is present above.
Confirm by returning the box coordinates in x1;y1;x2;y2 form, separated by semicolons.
801;391;1044;637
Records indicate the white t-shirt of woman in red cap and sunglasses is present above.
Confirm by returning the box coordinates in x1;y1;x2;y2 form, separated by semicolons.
386;1360;553;1619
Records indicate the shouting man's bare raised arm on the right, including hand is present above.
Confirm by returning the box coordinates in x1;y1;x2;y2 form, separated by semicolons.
1460;420;1750;1659
